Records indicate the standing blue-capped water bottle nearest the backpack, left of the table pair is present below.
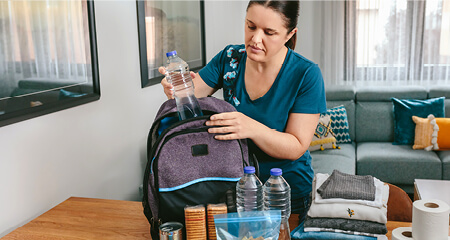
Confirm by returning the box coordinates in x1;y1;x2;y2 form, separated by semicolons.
236;166;264;212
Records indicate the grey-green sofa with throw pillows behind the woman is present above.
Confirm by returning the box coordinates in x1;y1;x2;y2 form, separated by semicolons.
311;86;450;194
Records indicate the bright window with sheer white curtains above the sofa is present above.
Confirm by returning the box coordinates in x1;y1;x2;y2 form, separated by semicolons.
347;0;450;85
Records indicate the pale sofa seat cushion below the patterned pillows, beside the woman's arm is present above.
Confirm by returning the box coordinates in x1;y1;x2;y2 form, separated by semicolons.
311;143;356;174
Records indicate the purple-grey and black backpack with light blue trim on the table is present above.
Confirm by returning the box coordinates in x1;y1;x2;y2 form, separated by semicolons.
142;97;257;239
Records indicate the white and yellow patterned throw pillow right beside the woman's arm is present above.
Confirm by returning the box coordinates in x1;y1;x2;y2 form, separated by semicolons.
308;115;339;152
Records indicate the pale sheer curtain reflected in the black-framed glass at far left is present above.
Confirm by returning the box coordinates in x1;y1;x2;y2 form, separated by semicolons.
0;0;90;99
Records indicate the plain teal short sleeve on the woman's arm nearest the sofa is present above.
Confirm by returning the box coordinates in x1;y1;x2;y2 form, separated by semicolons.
291;64;327;114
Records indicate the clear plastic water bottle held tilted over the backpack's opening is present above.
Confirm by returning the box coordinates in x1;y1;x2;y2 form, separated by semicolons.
165;51;203;120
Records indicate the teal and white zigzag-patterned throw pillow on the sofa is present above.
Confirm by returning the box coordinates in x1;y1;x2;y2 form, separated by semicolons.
322;105;352;143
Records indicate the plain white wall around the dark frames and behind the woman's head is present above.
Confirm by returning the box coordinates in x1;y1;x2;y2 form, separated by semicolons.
0;0;316;237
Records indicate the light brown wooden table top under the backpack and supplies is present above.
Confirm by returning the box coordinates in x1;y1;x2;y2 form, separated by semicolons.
2;197;442;240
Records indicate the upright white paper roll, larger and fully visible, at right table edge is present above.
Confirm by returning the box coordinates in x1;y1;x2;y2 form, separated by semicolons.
412;199;450;240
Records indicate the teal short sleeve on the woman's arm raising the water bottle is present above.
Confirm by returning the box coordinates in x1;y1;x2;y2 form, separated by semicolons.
198;46;230;89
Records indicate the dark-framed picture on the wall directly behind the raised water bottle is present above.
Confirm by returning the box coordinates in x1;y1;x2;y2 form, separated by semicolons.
136;0;206;88
